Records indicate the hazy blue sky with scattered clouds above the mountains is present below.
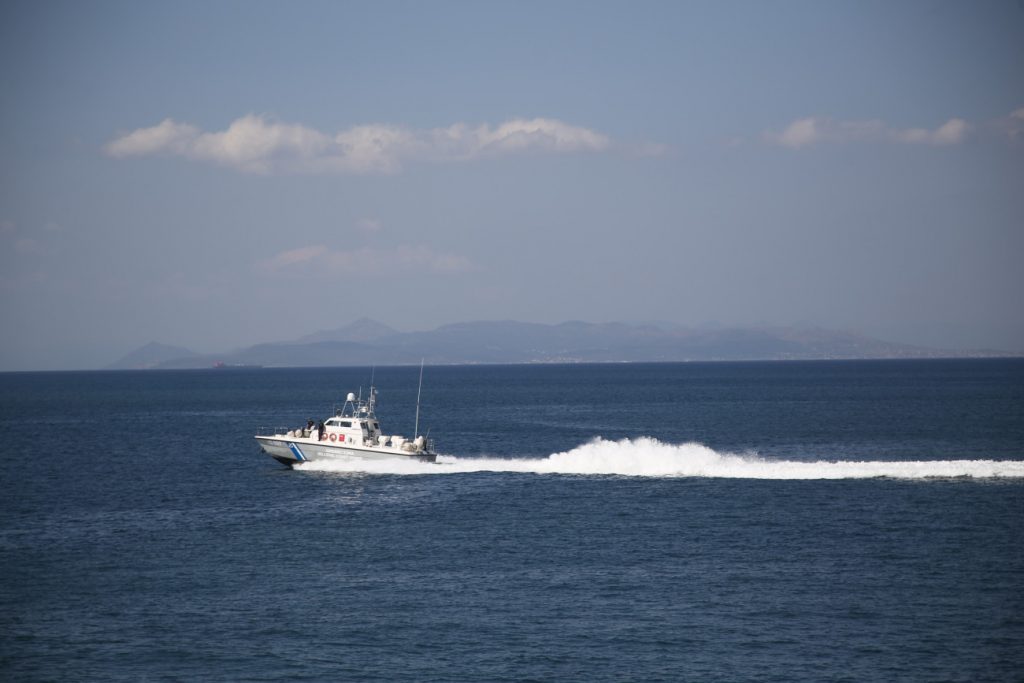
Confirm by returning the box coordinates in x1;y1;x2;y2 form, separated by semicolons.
0;2;1024;370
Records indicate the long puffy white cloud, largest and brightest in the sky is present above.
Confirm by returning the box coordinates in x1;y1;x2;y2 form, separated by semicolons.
104;115;611;173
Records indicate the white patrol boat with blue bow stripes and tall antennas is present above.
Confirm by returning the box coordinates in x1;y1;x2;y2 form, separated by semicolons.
256;387;437;467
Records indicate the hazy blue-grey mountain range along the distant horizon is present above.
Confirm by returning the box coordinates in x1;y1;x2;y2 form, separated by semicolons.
110;317;996;370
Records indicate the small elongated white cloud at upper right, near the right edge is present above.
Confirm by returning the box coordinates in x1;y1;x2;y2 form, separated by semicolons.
764;117;972;148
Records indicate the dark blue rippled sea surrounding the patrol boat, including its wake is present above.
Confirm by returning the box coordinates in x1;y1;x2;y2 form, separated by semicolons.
0;359;1024;682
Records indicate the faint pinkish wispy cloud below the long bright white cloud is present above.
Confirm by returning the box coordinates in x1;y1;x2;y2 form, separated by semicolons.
257;245;476;276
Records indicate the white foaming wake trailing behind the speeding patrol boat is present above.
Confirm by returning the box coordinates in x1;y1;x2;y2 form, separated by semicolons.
296;437;1024;479
